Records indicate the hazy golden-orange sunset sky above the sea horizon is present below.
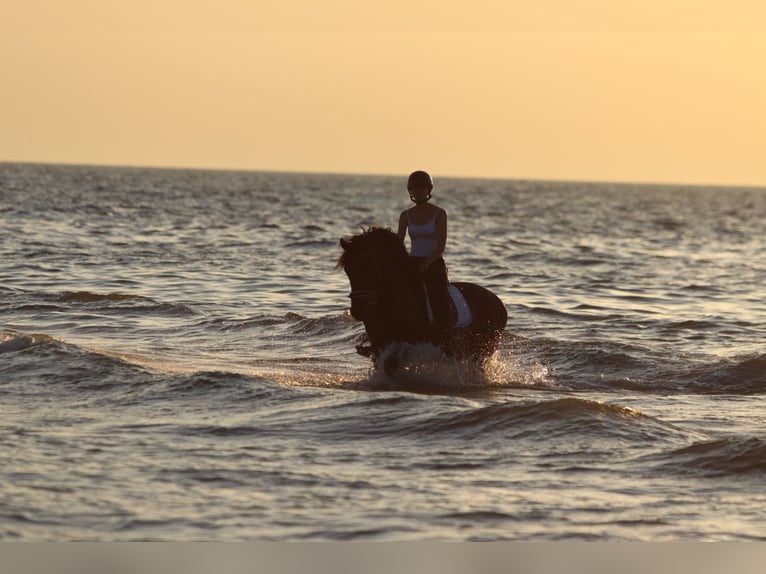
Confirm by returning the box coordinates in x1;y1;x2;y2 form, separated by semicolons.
0;0;766;186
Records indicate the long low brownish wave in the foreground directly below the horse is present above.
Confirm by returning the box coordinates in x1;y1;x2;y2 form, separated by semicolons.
240;382;699;450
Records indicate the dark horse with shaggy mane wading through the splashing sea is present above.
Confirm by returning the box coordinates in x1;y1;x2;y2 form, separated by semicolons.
338;227;508;363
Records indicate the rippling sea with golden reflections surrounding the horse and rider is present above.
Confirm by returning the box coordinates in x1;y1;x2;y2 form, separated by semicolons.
0;164;766;542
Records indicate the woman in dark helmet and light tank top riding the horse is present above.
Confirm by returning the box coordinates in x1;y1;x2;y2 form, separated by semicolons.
398;171;450;338
